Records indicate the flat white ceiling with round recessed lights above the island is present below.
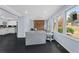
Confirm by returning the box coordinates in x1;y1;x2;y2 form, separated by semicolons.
8;5;63;19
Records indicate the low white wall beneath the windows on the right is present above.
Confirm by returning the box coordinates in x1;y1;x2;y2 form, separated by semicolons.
54;33;79;53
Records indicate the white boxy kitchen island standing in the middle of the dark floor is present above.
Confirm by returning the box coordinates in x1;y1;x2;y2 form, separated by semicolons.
25;31;46;46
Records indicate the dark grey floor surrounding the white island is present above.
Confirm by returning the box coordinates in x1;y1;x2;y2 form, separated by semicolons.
0;34;68;53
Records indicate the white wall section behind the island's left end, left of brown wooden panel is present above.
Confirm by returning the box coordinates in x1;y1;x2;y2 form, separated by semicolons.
17;16;32;38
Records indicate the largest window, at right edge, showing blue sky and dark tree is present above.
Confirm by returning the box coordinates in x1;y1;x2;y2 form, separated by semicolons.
66;6;79;38
